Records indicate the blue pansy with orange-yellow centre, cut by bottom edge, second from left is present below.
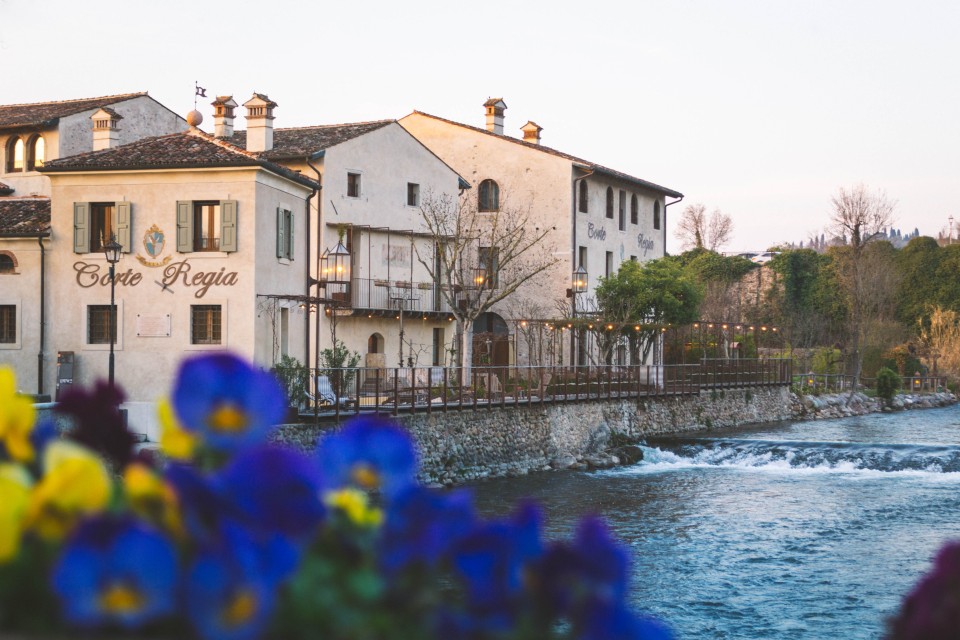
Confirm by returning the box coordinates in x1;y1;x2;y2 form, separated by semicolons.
185;526;293;640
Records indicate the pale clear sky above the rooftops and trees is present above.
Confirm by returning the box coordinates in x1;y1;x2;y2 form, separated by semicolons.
0;0;960;252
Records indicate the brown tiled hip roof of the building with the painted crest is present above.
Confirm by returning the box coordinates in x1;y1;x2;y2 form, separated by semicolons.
40;130;318;188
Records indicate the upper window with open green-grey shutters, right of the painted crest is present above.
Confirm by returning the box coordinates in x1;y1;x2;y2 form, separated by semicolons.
179;200;237;253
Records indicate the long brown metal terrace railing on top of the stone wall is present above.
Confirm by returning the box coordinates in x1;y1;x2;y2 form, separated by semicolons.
284;359;792;418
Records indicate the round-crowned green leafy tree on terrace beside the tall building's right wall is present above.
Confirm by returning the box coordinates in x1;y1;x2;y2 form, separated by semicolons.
596;258;701;364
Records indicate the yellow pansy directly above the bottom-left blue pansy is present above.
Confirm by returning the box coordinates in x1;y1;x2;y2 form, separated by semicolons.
26;440;112;540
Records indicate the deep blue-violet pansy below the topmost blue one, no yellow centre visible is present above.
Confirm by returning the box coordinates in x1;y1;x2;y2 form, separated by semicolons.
218;446;324;538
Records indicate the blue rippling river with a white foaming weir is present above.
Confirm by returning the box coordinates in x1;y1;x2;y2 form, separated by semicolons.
473;406;960;639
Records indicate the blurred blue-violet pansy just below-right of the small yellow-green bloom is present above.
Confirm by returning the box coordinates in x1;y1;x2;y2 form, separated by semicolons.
378;487;476;574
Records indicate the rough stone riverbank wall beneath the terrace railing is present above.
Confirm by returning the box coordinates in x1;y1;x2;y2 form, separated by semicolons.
277;387;792;485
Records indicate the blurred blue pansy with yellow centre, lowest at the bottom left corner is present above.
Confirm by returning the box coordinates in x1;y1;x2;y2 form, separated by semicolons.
52;517;177;628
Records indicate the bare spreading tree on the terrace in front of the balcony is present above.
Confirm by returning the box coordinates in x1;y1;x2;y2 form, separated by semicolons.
415;193;558;380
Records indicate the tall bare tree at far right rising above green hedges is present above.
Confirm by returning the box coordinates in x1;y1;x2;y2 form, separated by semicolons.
828;184;895;399
